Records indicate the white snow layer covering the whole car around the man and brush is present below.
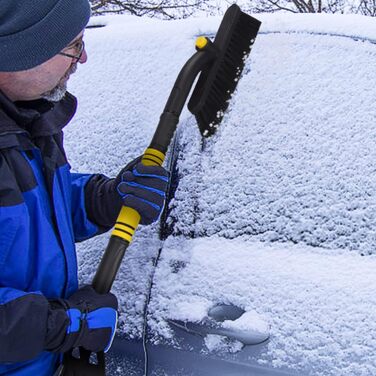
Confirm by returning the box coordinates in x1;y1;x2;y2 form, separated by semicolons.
65;10;376;376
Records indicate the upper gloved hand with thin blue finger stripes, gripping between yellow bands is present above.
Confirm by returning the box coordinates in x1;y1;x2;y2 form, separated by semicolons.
115;157;168;225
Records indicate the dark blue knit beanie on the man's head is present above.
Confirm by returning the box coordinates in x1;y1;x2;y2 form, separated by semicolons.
0;0;90;72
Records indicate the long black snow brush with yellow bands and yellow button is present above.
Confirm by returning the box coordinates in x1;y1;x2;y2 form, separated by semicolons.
61;4;261;376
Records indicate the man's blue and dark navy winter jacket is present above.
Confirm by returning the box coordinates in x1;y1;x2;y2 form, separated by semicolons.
0;92;121;376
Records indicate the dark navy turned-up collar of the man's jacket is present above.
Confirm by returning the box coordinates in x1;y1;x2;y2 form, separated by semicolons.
0;91;77;148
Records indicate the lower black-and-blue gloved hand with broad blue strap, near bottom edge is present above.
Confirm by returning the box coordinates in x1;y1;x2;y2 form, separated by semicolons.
45;286;118;352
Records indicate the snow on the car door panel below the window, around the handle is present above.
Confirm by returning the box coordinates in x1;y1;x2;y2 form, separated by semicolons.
150;236;376;375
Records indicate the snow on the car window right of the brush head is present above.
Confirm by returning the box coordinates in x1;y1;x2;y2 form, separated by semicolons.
173;33;376;254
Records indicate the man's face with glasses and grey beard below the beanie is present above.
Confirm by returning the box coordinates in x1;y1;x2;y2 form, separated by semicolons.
0;32;87;101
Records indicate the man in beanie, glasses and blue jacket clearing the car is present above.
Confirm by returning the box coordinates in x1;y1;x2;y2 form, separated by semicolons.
0;0;168;376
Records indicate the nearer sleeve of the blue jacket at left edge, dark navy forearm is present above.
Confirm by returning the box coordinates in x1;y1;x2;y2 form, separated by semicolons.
0;149;56;364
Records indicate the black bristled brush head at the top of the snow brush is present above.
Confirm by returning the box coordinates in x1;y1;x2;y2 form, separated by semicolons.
188;4;261;137
